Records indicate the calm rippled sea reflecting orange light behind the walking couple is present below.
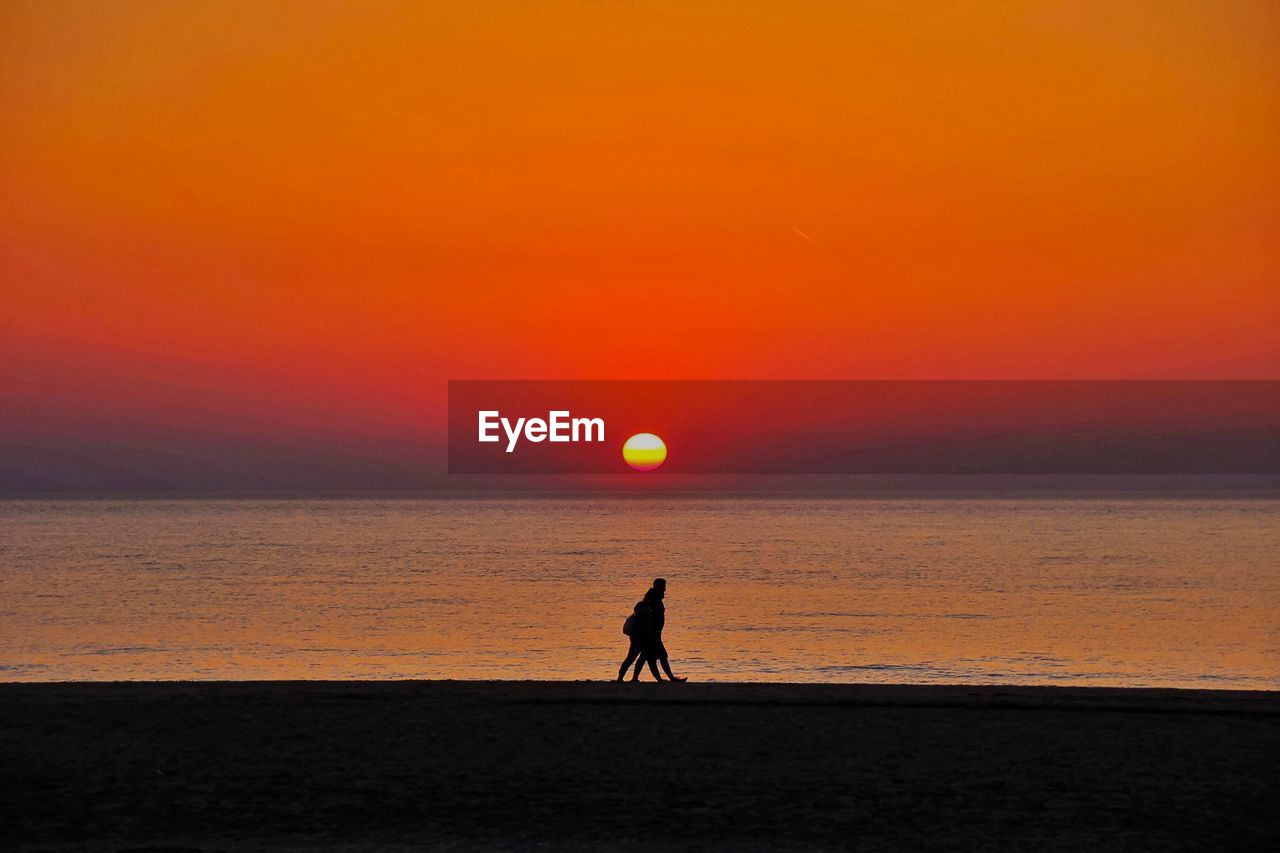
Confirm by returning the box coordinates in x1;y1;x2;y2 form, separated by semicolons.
0;497;1280;689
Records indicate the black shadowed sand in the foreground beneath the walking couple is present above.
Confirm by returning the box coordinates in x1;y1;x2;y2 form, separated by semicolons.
0;683;1280;850
